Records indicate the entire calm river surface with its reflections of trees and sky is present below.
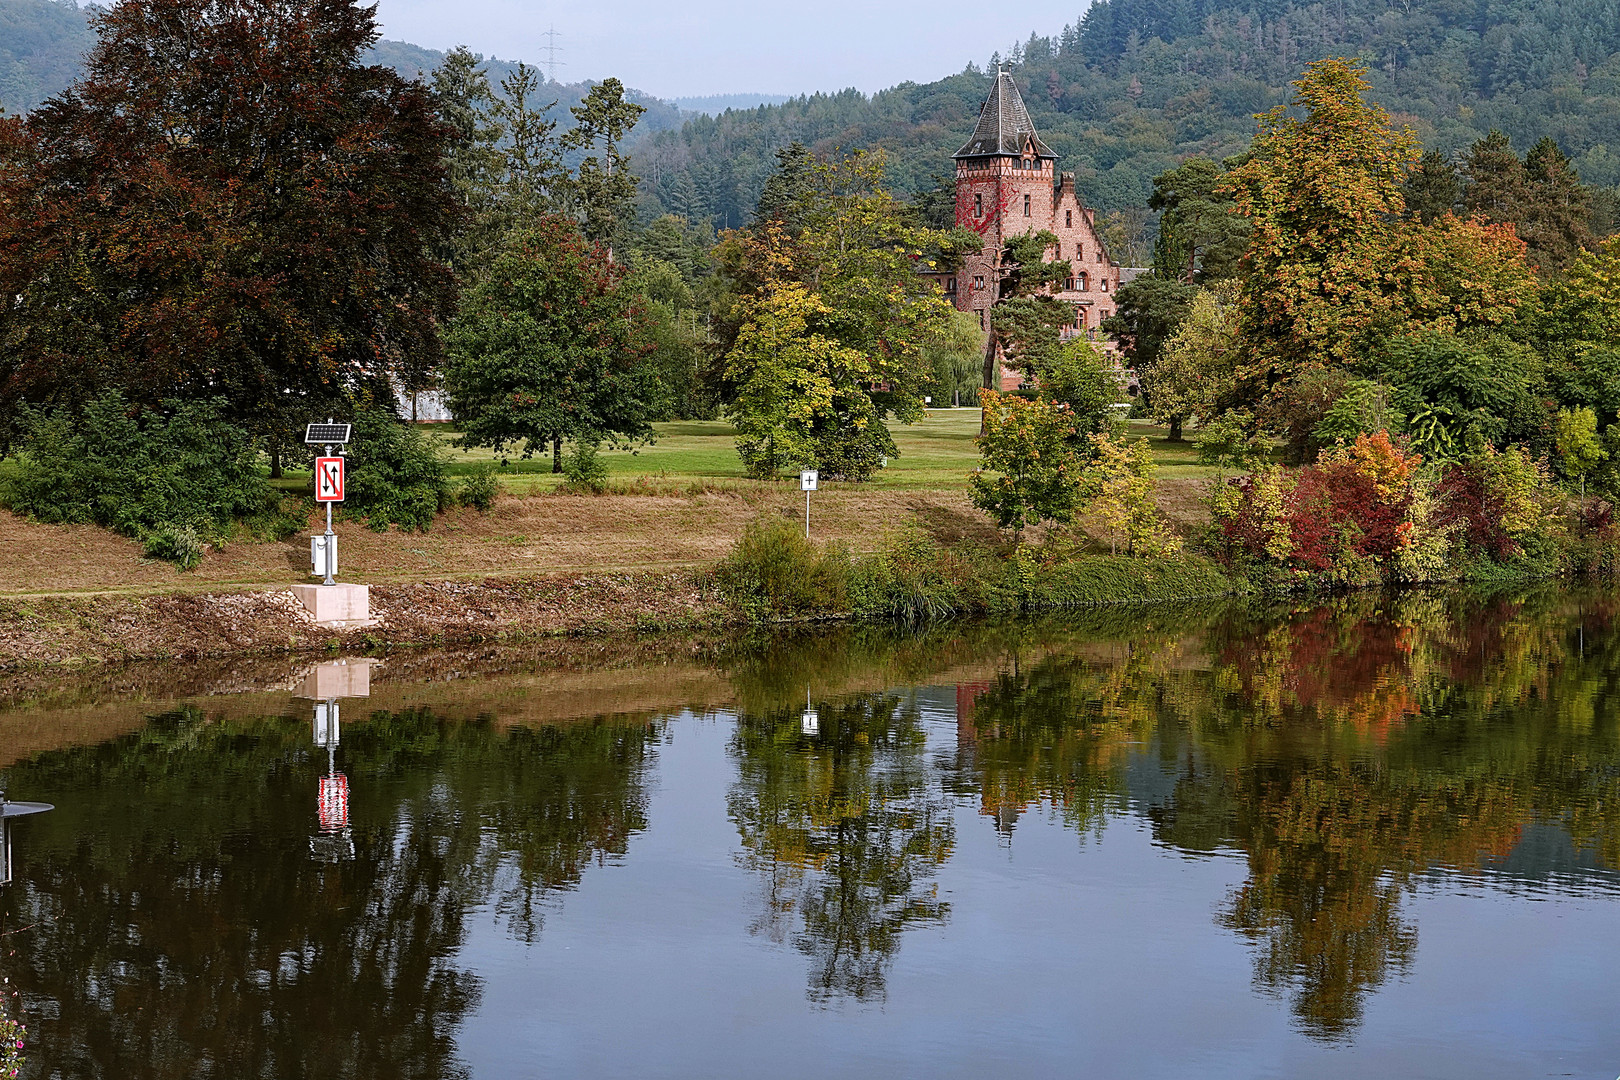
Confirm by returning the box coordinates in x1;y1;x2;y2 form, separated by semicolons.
0;591;1620;1080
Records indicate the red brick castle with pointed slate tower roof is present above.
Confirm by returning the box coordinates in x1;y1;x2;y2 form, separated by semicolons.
933;71;1119;390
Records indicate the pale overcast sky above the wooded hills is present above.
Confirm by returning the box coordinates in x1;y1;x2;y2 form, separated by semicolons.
377;0;1087;97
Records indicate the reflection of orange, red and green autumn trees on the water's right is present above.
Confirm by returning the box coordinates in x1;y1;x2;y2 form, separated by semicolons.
953;594;1620;1038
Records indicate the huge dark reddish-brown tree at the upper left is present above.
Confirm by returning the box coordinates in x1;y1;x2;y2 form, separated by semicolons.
0;0;457;443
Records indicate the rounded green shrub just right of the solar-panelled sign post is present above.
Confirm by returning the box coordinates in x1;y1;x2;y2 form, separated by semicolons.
343;408;454;533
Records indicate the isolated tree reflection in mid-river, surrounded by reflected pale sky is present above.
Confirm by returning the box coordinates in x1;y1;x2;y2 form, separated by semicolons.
727;695;956;1001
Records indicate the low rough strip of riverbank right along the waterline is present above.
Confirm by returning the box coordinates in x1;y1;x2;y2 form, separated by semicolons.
0;555;1594;675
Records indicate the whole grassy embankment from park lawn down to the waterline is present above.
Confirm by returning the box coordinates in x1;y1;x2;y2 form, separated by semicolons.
0;410;1226;670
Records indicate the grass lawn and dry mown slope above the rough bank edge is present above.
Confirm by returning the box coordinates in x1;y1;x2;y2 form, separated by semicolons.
0;410;1209;596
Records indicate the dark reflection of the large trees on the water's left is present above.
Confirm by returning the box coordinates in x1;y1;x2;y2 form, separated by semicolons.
5;711;650;1080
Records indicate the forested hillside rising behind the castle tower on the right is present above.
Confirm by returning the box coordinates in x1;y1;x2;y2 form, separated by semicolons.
637;0;1620;227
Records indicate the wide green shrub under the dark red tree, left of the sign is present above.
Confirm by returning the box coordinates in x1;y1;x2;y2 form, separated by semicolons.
3;390;281;567
